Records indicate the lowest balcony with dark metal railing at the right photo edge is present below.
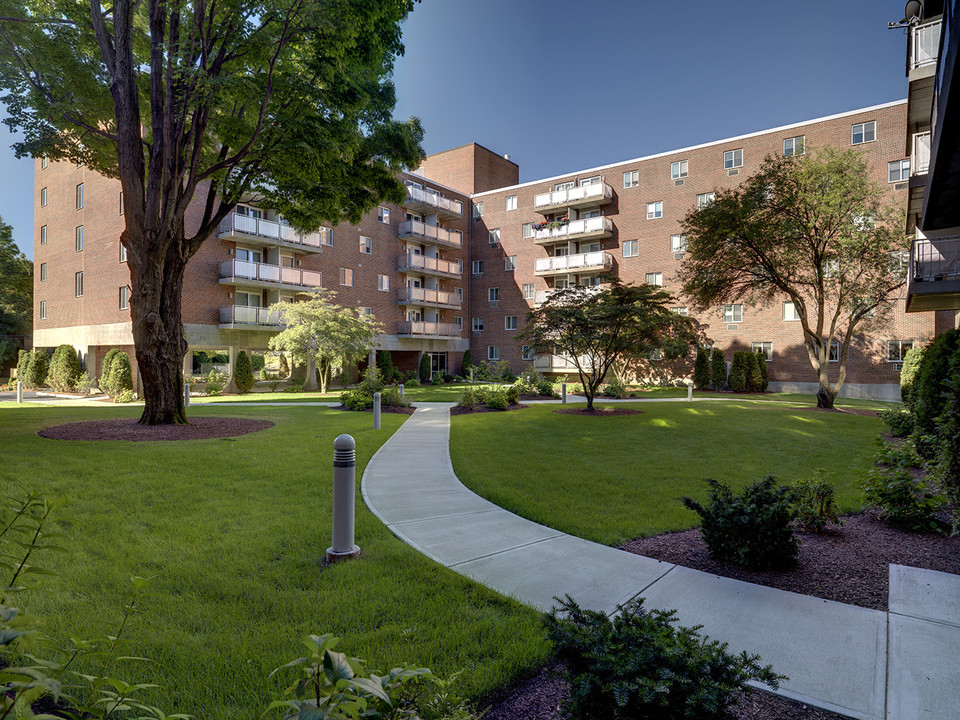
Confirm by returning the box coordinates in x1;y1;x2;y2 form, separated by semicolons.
907;235;960;312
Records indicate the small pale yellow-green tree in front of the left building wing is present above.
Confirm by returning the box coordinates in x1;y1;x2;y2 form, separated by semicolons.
270;288;383;392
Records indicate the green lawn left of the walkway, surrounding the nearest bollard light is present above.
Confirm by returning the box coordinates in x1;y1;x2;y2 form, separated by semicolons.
0;406;547;720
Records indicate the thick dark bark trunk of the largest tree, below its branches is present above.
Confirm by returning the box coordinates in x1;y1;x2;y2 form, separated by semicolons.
130;233;187;425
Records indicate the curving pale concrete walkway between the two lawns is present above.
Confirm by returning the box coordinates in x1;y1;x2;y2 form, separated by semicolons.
362;403;960;720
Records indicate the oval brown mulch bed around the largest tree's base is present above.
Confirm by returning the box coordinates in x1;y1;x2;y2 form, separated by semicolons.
37;417;273;442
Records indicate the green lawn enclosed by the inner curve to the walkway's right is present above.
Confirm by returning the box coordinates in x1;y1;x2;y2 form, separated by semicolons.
450;401;883;545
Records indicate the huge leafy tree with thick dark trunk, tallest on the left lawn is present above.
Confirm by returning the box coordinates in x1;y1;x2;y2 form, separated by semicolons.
0;0;423;424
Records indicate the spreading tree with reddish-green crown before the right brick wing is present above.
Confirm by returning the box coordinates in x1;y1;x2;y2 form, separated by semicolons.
680;148;910;408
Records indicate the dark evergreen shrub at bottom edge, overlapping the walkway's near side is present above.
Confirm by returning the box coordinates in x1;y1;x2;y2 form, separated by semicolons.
544;595;786;720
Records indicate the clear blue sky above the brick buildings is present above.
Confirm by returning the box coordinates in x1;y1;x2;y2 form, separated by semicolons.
0;0;906;256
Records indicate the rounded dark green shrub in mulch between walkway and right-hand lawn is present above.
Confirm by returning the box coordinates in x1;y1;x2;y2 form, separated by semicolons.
683;475;800;570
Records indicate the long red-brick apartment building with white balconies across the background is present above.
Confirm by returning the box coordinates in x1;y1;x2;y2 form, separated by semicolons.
34;101;956;398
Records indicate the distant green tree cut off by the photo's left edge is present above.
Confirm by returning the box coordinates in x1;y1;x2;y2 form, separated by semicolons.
0;219;33;363
